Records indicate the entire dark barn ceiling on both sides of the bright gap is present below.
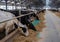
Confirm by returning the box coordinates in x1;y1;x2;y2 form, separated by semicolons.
0;0;60;8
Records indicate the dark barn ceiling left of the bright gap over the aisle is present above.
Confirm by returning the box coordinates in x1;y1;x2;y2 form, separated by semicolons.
0;0;45;7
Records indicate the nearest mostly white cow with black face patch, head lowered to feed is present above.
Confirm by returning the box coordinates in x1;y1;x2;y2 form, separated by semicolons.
0;11;29;36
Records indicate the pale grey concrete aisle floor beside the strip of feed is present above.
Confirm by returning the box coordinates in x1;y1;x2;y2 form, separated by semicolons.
39;10;60;42
